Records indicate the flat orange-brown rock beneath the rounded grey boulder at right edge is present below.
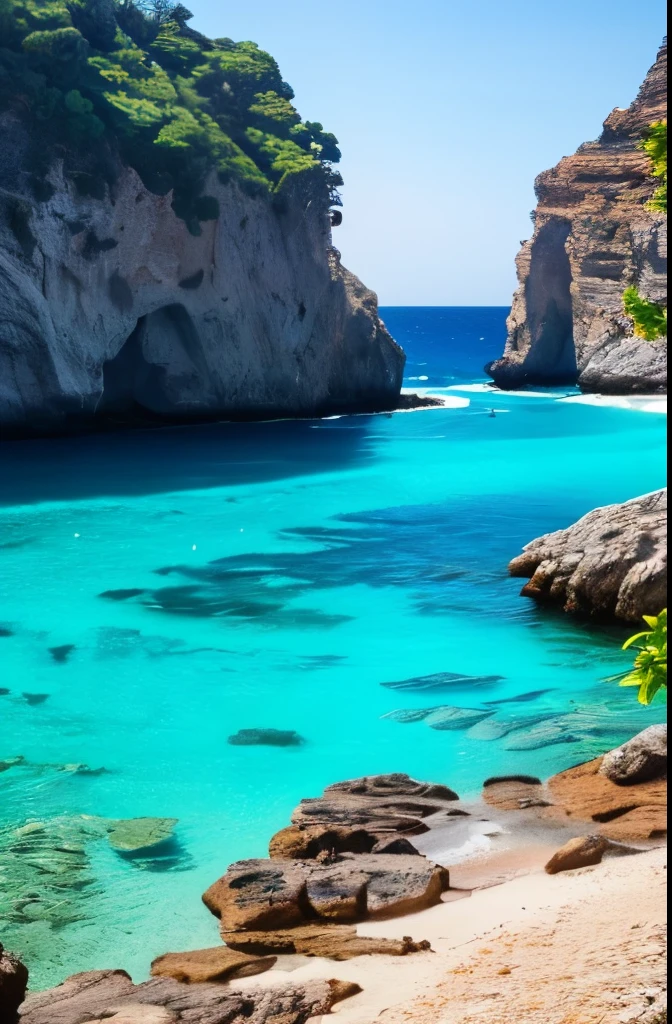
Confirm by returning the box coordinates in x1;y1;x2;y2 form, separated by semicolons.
548;758;667;839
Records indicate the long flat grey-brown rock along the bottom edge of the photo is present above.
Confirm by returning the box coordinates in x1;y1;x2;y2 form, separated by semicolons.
20;971;338;1024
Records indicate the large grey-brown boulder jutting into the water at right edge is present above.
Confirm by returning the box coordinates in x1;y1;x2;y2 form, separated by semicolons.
509;489;667;623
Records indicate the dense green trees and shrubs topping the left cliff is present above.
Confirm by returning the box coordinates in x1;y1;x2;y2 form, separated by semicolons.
0;0;342;232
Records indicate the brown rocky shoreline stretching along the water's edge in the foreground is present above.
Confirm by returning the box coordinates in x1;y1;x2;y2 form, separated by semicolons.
5;726;667;1024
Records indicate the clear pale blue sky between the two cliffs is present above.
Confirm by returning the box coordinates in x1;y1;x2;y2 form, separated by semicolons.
185;0;665;305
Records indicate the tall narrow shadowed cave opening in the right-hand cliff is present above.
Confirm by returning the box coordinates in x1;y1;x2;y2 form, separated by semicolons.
524;217;577;384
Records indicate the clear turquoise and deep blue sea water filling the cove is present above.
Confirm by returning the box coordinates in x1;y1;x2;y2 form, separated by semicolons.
0;309;665;987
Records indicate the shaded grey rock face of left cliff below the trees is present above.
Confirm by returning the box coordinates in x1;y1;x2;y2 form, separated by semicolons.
0;115;404;437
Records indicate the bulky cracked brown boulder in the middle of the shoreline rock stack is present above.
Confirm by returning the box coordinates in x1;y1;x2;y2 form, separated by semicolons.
203;853;450;933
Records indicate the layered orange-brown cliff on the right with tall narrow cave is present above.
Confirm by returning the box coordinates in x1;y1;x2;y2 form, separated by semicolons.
487;43;667;393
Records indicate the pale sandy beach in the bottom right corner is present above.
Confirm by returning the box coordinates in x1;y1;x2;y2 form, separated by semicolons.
240;846;667;1024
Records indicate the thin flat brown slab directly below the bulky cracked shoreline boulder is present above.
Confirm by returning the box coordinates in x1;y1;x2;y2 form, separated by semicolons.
221;924;431;961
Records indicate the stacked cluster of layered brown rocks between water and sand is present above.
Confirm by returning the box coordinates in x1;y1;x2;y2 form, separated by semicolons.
203;774;450;959
